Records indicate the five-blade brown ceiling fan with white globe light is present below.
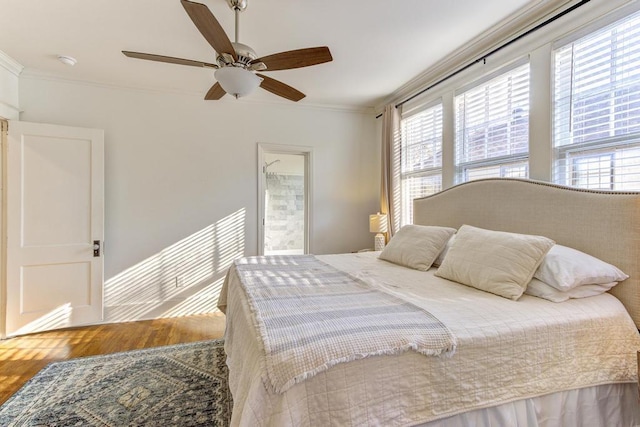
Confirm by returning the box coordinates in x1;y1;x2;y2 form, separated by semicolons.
122;0;333;102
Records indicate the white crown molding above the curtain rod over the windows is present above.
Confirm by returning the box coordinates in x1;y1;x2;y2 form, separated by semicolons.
375;0;578;112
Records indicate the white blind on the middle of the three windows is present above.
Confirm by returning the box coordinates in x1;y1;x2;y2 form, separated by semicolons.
455;63;529;183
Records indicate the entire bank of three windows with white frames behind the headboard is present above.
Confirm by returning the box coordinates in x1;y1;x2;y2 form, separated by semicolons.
392;2;640;219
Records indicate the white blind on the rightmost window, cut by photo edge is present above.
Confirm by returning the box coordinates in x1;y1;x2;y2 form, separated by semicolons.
553;9;640;190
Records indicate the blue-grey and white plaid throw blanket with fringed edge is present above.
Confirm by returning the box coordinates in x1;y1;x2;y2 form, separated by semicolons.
234;255;456;393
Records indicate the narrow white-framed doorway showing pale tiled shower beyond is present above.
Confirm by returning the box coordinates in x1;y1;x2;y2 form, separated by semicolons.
258;144;311;255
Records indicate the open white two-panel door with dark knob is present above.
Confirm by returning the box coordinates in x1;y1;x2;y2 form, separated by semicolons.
5;121;104;336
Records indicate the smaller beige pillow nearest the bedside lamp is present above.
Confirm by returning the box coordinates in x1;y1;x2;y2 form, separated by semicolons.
379;225;456;271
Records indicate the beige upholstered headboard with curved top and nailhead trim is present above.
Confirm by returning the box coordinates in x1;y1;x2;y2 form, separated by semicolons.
413;178;640;328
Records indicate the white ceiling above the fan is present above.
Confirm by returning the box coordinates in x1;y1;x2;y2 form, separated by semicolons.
0;0;540;108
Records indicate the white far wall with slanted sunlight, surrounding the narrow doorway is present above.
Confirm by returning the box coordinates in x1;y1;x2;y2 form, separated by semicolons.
20;76;379;321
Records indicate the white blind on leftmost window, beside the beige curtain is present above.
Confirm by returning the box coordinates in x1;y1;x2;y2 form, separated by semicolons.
400;104;442;226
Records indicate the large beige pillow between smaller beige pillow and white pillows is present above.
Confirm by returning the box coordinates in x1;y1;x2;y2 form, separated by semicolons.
435;225;555;300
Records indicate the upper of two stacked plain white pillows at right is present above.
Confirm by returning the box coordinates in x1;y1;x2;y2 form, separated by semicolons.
533;245;629;291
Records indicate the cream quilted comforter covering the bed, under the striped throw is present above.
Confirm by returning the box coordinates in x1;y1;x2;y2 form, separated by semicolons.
219;253;640;426
